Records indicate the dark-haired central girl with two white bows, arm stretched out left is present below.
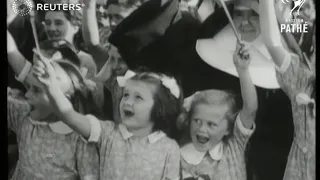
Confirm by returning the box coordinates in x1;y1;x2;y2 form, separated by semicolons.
32;51;183;180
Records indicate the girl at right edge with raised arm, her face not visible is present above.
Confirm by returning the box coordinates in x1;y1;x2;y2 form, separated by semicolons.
260;0;316;180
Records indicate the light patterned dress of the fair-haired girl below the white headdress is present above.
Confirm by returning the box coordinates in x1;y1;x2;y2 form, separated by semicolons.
181;115;255;180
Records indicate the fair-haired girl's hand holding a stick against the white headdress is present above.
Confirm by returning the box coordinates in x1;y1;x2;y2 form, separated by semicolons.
233;42;251;71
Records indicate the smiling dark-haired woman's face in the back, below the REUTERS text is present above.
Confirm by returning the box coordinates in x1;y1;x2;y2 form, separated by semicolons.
44;11;79;43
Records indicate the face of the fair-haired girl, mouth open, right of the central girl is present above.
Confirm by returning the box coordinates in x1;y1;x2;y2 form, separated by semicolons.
190;104;229;152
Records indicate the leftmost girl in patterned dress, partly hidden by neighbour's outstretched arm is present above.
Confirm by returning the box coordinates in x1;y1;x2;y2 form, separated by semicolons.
7;28;99;180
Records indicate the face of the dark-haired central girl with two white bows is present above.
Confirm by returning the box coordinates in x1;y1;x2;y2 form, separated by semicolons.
120;80;156;130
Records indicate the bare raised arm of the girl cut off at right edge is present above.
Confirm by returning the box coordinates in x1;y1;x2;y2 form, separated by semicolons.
259;0;291;68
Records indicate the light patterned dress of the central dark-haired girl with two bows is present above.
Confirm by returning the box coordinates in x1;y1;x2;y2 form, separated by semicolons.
87;115;180;180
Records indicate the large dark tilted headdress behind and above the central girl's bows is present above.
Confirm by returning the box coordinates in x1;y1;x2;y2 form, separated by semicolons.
109;0;179;58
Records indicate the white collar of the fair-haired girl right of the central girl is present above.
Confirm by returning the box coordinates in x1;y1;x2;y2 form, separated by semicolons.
180;142;223;165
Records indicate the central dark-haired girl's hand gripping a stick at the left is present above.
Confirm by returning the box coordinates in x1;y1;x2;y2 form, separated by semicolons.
32;56;60;89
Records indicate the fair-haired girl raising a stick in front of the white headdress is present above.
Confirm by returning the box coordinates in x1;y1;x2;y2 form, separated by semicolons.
179;40;258;180
